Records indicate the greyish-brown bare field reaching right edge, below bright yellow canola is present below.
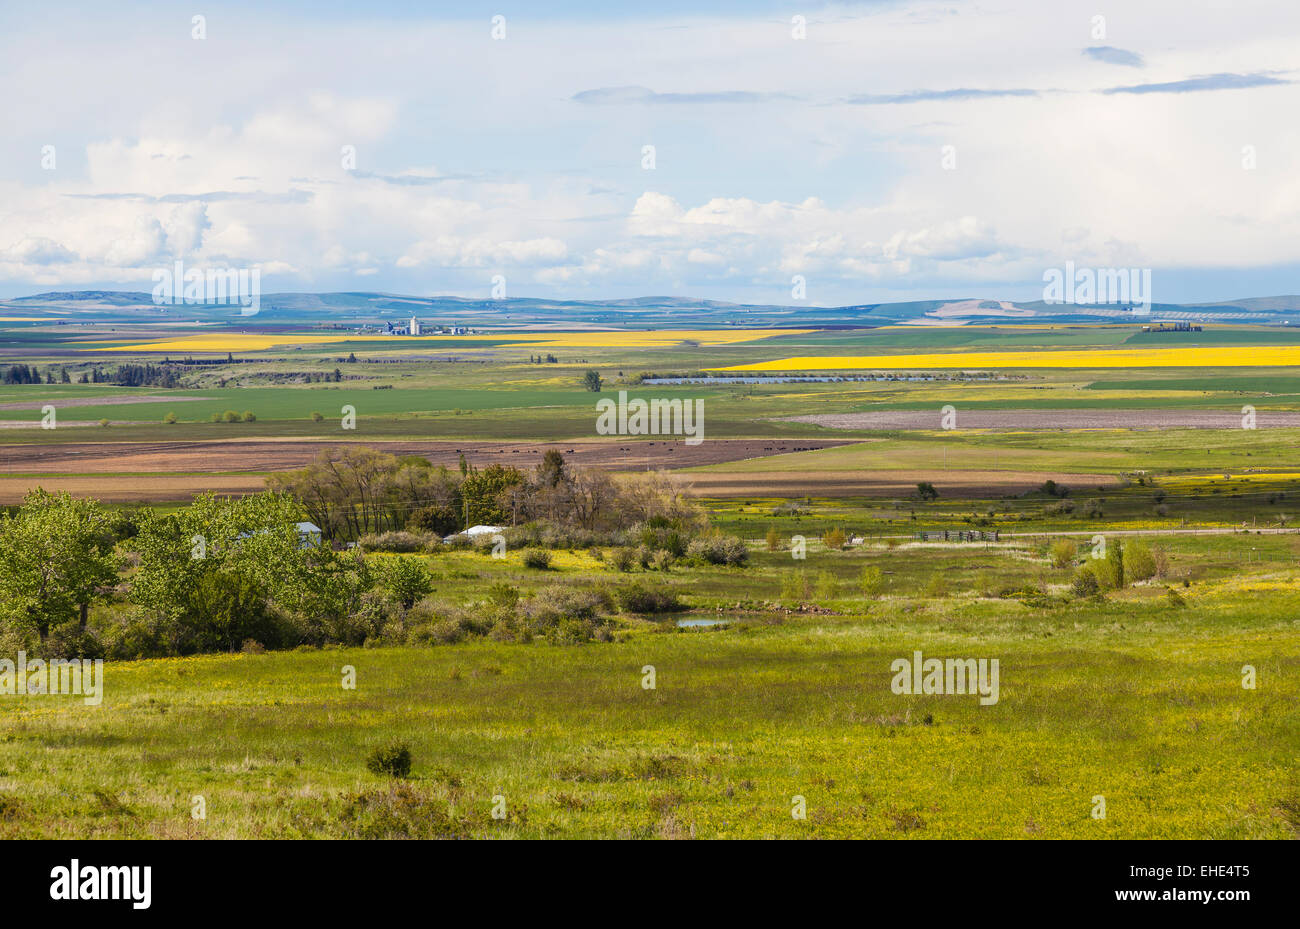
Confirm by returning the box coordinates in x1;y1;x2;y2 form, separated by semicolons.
788;408;1300;430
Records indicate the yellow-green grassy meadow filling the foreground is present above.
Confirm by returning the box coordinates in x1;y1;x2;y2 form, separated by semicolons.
0;537;1300;838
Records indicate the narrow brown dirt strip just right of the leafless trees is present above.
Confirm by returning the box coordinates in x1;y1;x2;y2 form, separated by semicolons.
683;469;1118;499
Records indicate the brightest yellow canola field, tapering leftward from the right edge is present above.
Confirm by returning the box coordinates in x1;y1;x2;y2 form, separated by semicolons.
714;346;1300;372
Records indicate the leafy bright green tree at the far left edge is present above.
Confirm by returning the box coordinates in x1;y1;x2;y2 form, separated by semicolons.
0;489;117;642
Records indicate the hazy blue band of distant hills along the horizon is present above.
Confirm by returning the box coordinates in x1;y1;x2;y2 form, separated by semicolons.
0;290;1300;327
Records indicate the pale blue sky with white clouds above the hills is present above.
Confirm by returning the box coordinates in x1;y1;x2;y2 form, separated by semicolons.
0;0;1300;305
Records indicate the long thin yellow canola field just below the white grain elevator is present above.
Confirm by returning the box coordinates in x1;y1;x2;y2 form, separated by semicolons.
96;329;810;352
